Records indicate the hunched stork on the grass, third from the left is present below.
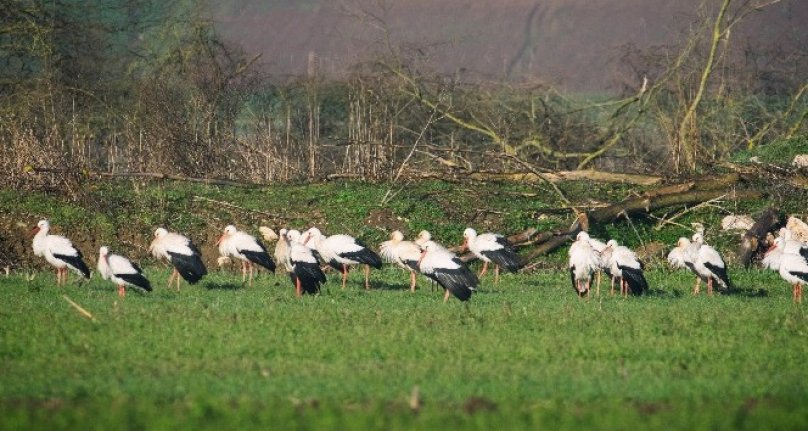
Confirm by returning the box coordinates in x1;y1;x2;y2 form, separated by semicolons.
149;228;208;290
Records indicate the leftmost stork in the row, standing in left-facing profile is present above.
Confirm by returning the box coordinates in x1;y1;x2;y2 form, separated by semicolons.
31;220;90;286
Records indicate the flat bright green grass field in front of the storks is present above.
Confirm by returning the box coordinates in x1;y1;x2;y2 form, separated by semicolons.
0;266;808;430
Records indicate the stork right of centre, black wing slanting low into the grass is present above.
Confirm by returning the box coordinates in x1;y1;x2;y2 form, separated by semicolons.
418;240;480;302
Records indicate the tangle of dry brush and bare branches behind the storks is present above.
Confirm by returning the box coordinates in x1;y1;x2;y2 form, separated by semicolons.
0;0;808;195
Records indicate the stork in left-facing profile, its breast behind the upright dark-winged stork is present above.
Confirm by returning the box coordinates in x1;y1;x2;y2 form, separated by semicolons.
303;227;382;289
